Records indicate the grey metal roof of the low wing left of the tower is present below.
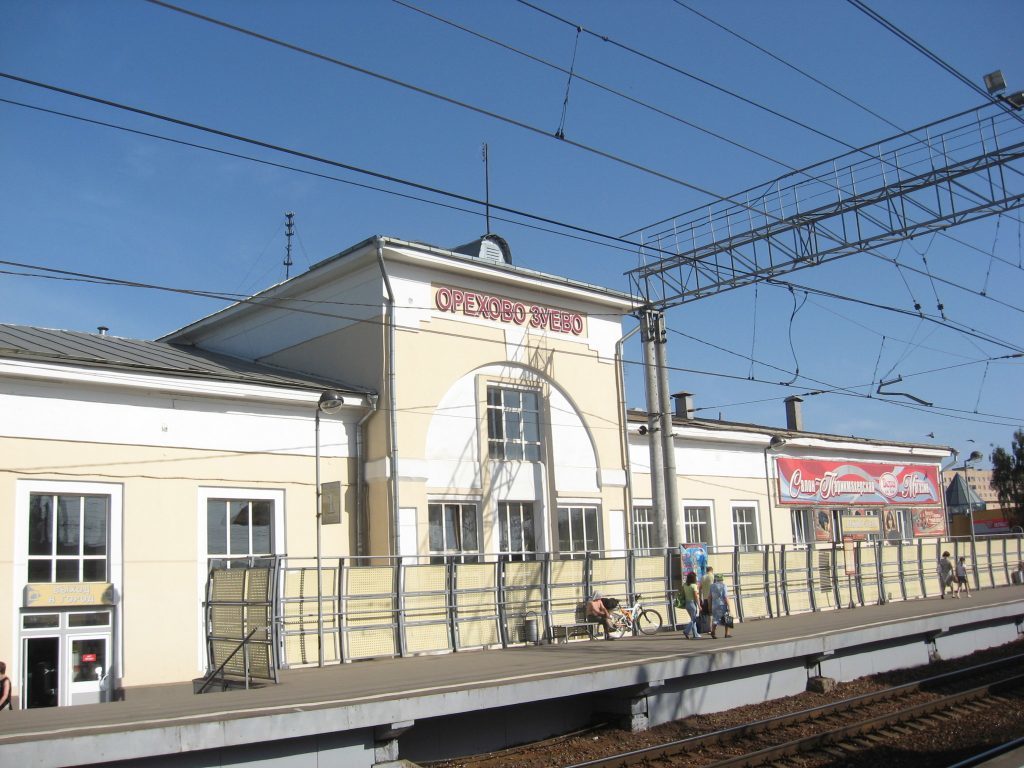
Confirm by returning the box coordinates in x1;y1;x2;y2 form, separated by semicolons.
0;324;368;393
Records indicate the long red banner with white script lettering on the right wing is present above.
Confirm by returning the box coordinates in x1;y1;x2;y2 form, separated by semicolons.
775;457;942;507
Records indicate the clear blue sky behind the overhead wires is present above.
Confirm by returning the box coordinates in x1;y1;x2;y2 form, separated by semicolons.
0;0;1024;462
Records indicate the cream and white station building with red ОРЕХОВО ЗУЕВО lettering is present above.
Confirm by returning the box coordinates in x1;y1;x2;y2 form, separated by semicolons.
0;236;950;707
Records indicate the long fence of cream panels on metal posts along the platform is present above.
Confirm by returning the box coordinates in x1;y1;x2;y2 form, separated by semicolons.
256;537;1024;668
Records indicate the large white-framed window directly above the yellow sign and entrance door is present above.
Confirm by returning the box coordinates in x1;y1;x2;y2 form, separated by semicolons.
28;494;111;583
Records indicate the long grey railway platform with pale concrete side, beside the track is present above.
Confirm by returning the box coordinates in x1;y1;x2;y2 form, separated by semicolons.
0;586;1024;768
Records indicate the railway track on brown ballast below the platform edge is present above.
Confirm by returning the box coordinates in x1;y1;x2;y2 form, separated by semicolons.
566;654;1024;768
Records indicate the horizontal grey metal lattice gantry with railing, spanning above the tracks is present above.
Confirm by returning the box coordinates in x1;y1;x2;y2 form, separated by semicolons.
627;104;1024;309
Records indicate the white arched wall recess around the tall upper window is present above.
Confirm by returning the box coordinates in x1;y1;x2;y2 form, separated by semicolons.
424;365;599;500
